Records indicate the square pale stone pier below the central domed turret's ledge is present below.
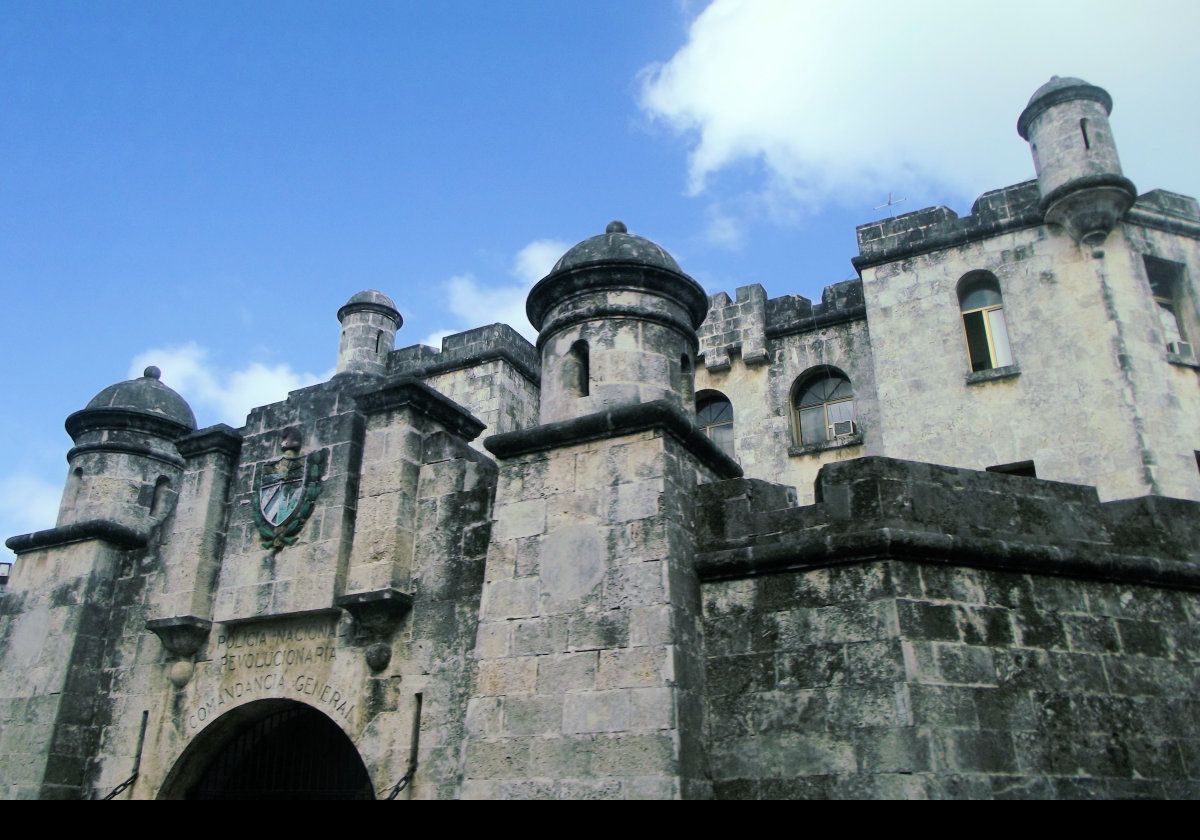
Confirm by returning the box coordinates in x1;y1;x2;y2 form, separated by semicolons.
463;427;712;799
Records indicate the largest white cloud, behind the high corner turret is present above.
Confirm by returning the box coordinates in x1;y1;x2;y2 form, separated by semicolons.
641;0;1200;214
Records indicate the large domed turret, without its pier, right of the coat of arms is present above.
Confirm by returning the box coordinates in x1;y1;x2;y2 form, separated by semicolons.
526;222;708;424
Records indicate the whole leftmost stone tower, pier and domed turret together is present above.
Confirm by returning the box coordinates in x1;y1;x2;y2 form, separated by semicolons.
0;367;196;799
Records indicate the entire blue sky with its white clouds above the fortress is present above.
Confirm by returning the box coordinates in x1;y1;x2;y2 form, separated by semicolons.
0;0;1200;556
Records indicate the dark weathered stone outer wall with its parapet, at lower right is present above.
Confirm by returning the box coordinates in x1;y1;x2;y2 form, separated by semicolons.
697;458;1200;799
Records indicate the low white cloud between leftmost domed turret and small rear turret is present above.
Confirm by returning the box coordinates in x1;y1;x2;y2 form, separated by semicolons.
128;342;334;426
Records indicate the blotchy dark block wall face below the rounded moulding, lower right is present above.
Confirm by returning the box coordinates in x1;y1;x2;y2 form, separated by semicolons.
704;562;1200;799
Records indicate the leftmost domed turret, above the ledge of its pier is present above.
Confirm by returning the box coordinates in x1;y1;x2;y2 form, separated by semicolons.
58;366;196;530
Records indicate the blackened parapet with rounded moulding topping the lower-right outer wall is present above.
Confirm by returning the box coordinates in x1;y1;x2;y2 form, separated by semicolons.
697;457;1200;589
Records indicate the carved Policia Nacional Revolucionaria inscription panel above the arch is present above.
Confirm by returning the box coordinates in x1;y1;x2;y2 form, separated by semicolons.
187;618;355;731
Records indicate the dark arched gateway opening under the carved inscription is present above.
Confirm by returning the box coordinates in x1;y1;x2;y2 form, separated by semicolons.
161;700;374;799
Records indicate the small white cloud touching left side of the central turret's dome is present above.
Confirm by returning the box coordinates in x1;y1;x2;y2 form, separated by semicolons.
422;239;569;347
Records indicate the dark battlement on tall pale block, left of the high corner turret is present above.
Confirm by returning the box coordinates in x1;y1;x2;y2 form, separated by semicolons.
851;181;1042;271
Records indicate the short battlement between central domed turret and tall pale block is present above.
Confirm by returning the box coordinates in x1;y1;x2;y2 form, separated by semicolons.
698;278;866;371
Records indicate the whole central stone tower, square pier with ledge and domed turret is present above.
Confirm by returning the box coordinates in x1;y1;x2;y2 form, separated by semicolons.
463;222;740;798
